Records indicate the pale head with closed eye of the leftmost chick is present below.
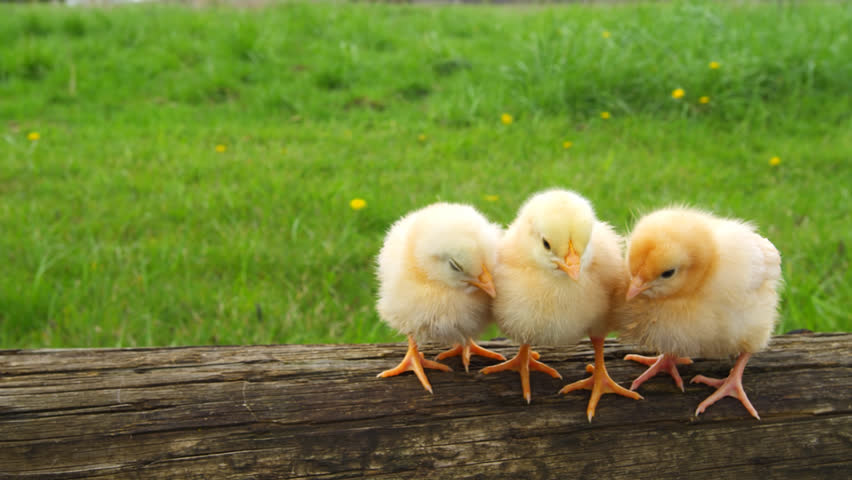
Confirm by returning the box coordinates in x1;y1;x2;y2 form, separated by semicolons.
410;203;500;298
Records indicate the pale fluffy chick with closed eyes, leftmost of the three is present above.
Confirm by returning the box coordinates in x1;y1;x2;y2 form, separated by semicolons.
376;203;505;393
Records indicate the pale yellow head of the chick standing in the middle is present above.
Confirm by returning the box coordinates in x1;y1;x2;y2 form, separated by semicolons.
516;190;597;280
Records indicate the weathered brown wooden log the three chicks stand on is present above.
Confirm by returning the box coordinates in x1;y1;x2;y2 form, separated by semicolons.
0;334;852;479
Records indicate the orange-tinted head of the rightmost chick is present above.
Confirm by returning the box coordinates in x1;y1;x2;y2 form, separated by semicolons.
627;208;716;300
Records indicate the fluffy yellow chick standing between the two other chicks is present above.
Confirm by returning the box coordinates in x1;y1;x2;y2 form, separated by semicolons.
482;190;641;421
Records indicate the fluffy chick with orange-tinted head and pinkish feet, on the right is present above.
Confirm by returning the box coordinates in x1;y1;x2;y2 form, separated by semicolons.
622;208;781;419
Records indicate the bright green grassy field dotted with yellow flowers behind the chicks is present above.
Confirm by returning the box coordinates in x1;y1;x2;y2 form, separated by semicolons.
0;2;852;348
